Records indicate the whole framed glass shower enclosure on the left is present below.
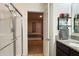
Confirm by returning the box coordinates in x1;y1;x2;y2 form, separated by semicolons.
0;3;23;56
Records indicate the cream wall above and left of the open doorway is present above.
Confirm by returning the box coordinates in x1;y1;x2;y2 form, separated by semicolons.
14;3;45;55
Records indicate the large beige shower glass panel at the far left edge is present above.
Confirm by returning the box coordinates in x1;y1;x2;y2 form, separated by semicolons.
0;4;14;56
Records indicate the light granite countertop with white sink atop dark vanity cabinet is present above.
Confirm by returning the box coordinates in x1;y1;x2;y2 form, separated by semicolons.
57;39;79;52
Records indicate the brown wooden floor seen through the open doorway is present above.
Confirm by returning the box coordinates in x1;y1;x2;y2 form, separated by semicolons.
28;40;43;56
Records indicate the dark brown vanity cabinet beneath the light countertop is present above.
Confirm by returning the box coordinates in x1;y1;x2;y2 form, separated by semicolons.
56;41;79;56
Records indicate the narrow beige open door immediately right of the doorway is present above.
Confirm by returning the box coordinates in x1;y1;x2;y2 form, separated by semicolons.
43;4;49;56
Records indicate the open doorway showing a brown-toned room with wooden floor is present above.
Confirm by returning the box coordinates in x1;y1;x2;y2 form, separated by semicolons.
28;12;43;56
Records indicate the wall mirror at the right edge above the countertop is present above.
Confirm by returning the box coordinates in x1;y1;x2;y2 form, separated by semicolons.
71;3;79;34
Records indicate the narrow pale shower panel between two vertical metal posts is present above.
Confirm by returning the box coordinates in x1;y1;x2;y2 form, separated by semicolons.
15;16;22;56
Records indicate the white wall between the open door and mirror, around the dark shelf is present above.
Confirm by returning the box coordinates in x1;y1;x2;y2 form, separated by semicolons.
49;3;71;56
